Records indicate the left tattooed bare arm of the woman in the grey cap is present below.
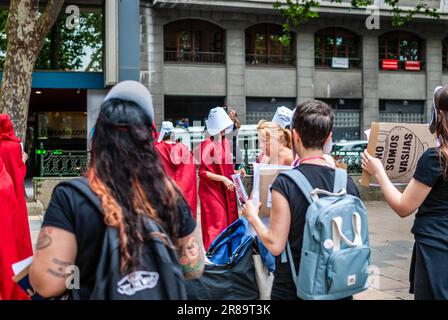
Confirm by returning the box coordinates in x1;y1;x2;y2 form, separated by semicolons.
30;227;77;298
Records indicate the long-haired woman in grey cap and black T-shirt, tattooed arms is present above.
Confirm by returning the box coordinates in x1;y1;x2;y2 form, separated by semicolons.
30;82;203;299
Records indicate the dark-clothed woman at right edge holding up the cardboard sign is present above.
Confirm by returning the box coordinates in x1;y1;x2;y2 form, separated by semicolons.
362;86;448;300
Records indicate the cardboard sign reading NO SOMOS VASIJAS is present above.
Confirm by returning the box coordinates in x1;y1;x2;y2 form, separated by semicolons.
361;122;436;187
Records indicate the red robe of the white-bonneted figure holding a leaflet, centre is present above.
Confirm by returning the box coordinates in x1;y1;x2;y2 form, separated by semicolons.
199;138;238;250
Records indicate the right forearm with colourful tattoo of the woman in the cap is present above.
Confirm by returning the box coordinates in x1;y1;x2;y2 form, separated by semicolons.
176;228;204;280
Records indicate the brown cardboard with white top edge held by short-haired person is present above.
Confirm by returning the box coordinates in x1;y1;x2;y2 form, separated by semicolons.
257;165;291;217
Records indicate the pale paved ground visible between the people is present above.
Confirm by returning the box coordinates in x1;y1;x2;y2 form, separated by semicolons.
30;202;414;300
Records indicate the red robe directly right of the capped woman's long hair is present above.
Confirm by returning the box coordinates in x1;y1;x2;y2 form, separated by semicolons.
156;141;198;220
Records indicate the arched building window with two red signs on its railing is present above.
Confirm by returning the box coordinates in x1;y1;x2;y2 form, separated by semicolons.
379;31;424;71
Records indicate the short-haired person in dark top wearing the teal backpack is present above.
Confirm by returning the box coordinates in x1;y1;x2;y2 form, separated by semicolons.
243;101;359;300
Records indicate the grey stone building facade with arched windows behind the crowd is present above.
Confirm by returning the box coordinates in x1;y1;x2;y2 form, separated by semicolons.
140;0;448;140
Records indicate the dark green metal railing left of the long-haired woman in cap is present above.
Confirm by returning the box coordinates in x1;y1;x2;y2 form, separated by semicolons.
40;147;88;177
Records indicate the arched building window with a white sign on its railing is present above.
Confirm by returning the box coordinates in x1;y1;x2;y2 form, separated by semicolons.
314;28;361;69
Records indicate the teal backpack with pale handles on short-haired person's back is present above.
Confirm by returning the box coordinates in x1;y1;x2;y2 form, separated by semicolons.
281;169;370;300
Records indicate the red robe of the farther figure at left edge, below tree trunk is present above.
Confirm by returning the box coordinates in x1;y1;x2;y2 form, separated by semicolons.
0;114;33;260
